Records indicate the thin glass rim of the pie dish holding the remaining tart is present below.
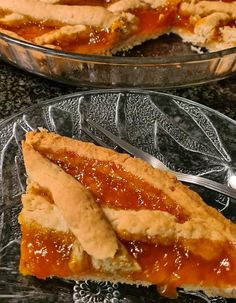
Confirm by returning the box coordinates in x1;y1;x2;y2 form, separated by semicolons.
0;32;236;66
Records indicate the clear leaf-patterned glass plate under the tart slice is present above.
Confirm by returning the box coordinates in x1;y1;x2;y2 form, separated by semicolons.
0;90;236;303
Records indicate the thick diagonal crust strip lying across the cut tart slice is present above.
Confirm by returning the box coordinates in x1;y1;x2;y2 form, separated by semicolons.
22;143;118;259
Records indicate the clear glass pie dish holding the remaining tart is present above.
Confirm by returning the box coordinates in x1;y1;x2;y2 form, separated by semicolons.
0;33;236;89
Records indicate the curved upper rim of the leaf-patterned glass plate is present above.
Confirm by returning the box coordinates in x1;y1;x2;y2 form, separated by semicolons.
0;88;236;131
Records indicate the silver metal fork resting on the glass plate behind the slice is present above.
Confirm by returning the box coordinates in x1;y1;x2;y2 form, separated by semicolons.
83;119;236;199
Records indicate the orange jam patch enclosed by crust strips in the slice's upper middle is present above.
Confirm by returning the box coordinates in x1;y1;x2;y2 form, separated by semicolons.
40;150;188;222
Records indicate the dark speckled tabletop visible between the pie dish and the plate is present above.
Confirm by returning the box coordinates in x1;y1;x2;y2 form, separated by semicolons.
0;62;236;121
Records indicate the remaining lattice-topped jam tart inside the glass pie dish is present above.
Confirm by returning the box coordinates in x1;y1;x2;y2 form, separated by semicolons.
0;0;236;55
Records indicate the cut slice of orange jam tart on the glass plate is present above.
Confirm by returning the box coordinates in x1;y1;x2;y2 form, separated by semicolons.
19;131;236;297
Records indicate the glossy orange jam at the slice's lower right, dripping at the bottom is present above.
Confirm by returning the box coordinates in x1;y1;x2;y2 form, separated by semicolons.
124;240;236;297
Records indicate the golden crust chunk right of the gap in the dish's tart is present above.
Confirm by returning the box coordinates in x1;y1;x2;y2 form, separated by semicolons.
176;0;236;51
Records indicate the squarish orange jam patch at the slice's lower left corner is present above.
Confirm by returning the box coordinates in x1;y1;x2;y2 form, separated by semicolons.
20;224;74;279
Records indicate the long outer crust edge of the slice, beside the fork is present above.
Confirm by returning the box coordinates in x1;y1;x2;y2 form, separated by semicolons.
26;132;236;239
